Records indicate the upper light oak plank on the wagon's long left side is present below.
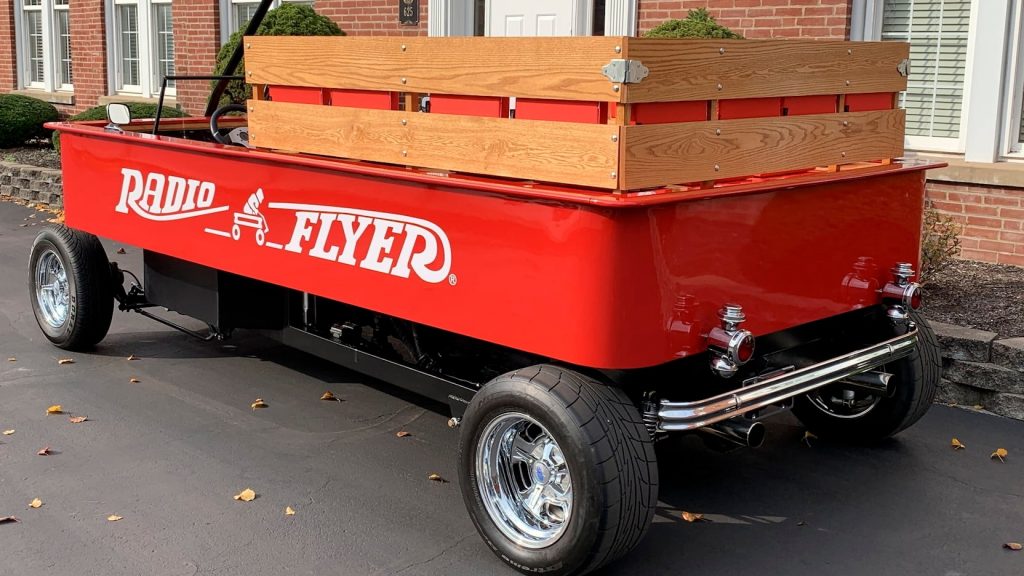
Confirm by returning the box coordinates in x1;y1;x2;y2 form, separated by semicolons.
246;36;624;101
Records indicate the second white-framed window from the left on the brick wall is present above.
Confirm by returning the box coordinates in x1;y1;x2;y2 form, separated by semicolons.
109;0;174;97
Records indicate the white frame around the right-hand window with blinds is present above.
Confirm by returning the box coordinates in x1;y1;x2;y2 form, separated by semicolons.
850;0;984;154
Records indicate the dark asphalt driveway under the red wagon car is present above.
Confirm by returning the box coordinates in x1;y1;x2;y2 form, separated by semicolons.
0;198;1024;576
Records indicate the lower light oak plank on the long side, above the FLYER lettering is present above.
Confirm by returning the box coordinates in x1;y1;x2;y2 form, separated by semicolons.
249;100;621;189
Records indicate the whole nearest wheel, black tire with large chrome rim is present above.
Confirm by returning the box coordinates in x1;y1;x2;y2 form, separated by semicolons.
459;365;657;576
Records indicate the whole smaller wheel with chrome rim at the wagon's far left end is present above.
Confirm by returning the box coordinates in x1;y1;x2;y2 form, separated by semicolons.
29;225;114;351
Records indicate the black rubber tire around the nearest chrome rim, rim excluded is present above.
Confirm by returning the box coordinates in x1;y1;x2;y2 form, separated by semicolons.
459;365;657;576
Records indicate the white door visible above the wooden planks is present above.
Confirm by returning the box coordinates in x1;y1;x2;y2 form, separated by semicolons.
486;0;591;36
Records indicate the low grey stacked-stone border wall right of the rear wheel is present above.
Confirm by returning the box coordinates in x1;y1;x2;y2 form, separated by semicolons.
931;321;1024;420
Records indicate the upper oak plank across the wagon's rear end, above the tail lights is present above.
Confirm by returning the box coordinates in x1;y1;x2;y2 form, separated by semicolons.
622;38;910;102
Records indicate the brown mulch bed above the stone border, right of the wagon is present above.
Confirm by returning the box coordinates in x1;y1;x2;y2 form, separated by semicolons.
923;260;1024;338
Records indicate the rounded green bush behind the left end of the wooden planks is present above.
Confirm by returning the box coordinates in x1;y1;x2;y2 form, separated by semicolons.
210;4;345;106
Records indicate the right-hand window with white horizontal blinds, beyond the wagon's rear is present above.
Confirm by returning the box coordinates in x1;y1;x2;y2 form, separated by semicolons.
882;0;971;152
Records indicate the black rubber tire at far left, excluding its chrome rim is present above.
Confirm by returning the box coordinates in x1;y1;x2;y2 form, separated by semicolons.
29;224;114;351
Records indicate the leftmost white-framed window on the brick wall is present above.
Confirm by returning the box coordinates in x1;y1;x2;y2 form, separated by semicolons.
16;0;73;92
